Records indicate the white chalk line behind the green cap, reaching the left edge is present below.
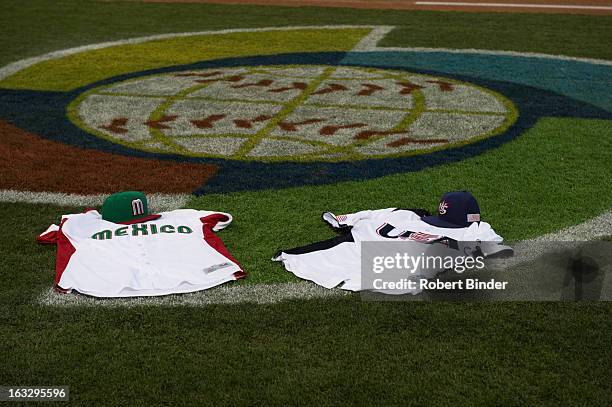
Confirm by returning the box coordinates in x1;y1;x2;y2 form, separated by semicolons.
0;189;191;212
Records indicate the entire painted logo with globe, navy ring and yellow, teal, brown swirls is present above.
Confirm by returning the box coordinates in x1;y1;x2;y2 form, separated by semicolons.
0;26;612;195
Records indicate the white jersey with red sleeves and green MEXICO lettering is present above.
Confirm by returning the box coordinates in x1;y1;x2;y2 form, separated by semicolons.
37;209;245;297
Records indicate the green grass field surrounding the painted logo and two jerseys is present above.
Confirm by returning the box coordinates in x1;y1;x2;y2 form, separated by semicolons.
0;0;612;406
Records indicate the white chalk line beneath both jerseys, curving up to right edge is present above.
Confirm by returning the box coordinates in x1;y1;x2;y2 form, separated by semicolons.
38;211;612;307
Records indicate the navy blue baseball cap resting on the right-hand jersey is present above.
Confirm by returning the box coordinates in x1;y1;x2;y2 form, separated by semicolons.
421;191;480;228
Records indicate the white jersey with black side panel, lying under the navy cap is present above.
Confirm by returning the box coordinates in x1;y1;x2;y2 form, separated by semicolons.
272;208;509;294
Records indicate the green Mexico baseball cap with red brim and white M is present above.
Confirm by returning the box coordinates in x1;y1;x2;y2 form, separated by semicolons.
102;191;161;224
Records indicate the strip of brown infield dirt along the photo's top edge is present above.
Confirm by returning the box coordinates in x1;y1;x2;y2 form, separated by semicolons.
137;0;612;15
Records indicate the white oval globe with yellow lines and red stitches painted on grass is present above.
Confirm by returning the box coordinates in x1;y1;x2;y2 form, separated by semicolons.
69;65;517;161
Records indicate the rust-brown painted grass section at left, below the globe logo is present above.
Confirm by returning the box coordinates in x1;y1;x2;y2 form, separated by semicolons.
0;121;218;194
